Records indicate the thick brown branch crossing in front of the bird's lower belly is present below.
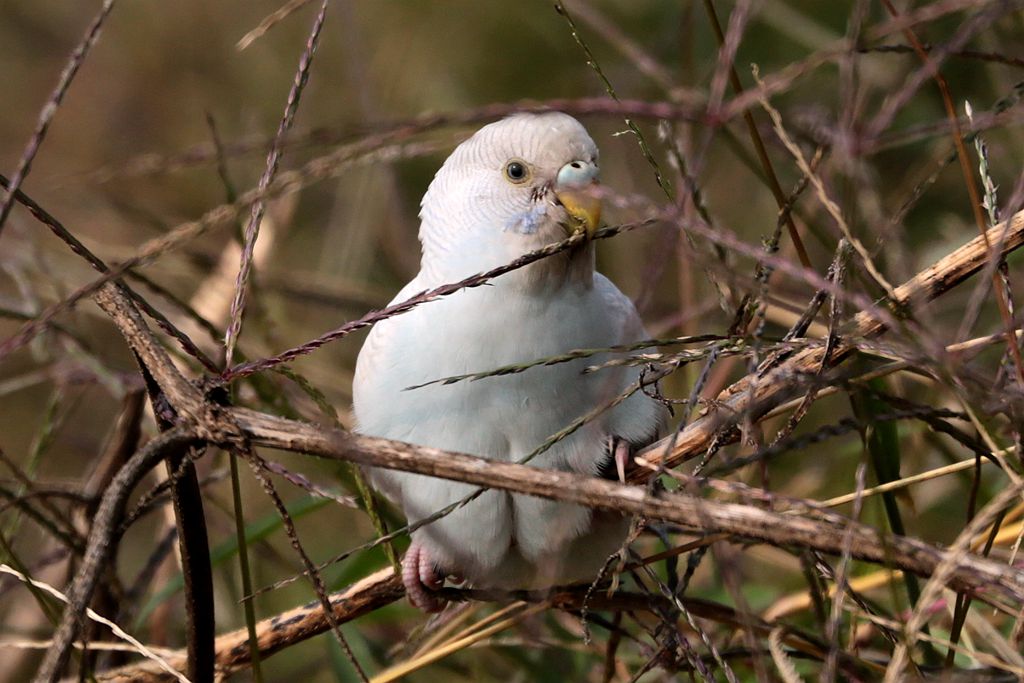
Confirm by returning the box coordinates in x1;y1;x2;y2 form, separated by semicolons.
228;408;1024;602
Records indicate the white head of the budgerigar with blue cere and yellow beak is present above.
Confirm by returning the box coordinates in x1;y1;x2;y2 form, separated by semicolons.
420;112;601;274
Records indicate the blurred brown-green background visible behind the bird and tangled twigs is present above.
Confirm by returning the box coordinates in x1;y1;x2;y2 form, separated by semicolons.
0;0;1024;681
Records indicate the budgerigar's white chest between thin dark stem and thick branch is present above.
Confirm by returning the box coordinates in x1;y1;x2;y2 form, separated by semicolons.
356;274;628;469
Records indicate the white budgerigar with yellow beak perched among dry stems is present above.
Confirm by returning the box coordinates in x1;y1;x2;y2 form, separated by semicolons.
352;112;668;612
